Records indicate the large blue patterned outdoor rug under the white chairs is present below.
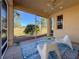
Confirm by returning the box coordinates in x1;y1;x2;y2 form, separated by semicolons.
21;39;79;59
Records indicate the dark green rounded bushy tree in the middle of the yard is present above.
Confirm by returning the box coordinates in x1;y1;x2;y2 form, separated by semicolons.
24;24;39;35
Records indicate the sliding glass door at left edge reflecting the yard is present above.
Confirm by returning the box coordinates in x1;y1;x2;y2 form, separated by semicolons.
1;0;7;57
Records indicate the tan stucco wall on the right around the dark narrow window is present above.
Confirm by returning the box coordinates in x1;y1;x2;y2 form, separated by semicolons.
52;5;79;43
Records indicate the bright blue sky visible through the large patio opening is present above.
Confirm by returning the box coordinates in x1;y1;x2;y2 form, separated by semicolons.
14;10;41;26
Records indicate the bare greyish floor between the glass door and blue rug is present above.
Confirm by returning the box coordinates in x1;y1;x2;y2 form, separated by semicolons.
4;46;23;59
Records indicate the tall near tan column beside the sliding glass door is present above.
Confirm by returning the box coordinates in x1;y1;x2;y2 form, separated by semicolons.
7;0;14;47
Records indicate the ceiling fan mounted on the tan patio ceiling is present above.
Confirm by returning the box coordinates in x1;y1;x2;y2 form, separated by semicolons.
44;0;63;12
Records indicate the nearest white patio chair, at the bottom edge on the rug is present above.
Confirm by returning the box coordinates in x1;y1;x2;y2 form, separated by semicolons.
37;42;61;59
